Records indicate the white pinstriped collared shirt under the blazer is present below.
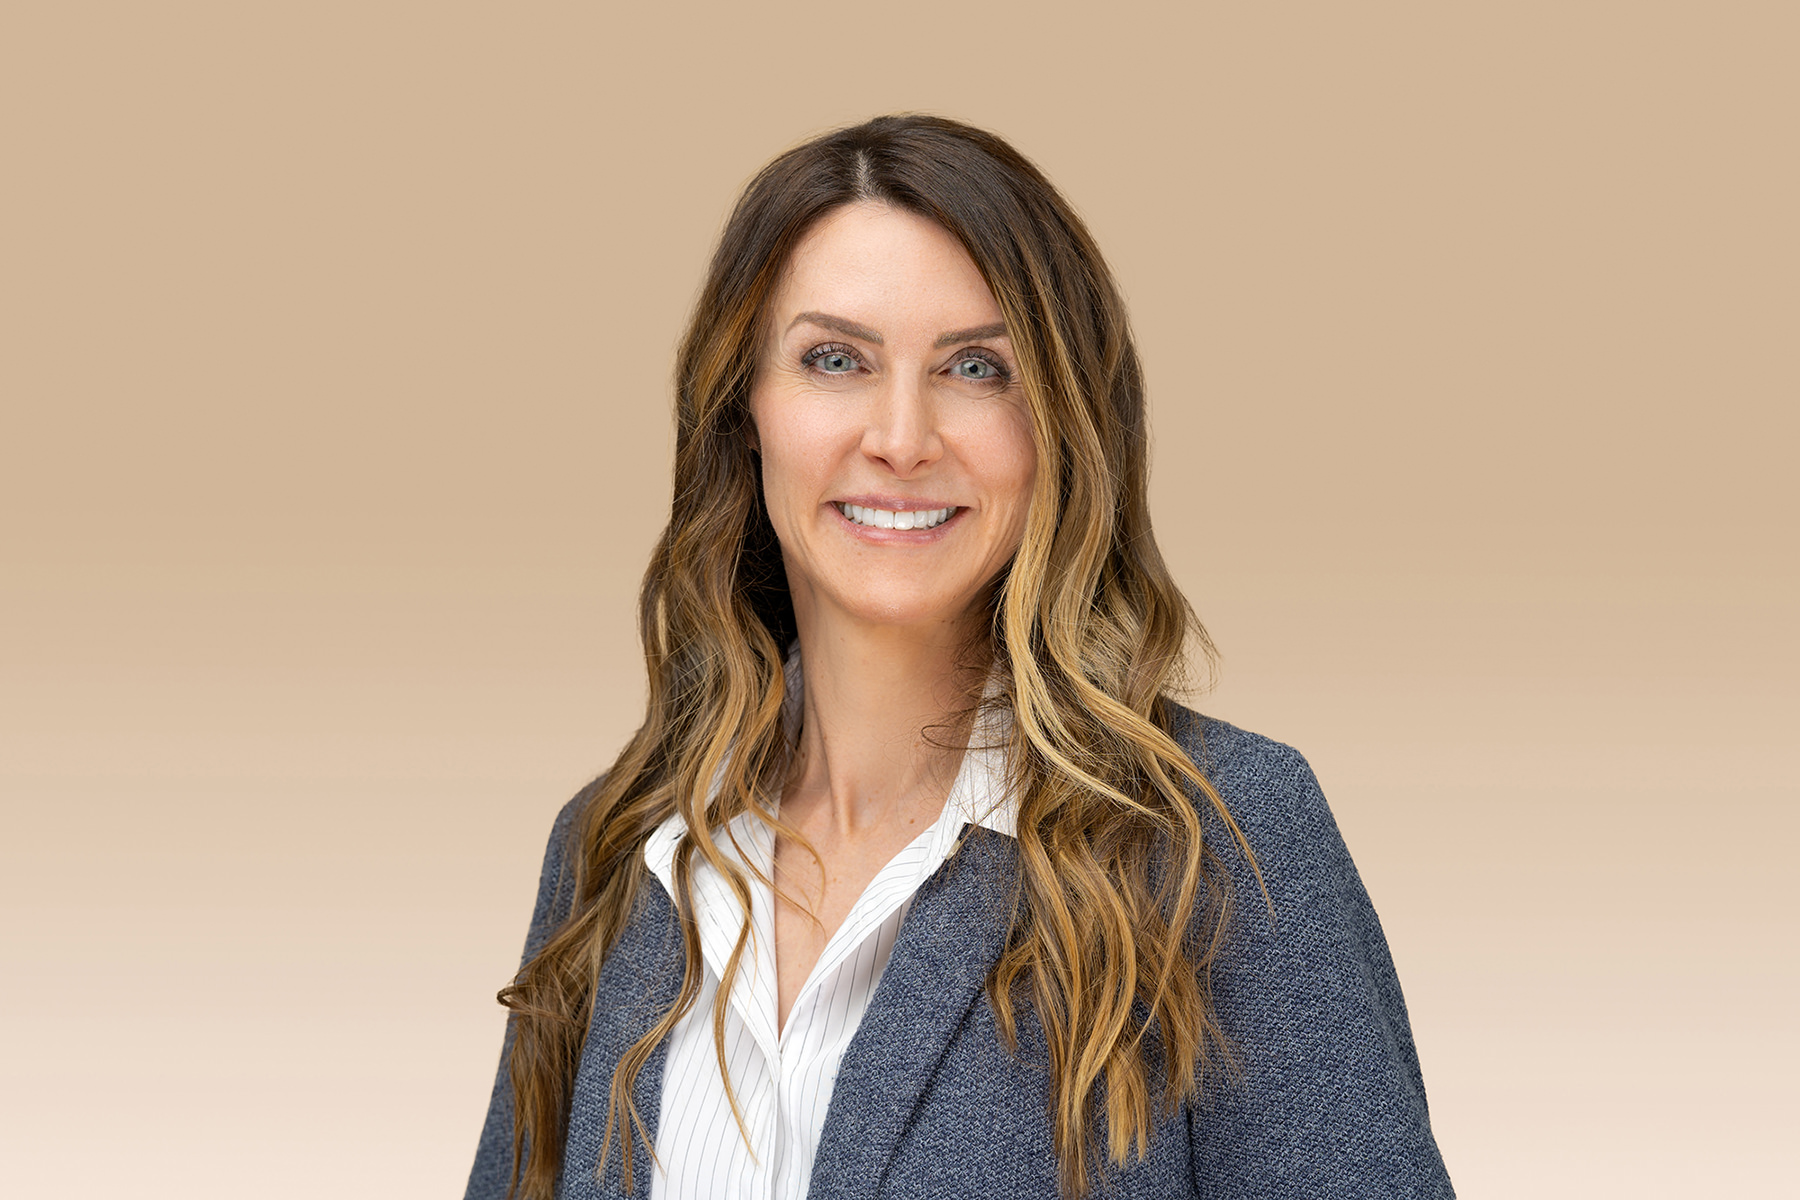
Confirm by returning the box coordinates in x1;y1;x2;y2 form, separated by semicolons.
644;655;1017;1200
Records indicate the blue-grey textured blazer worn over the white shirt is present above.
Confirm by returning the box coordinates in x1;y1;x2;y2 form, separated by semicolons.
466;711;1453;1200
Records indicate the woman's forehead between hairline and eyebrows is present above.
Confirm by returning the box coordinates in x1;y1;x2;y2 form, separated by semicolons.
770;203;1001;336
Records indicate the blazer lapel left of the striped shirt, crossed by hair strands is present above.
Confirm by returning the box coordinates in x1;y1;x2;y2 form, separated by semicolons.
558;878;682;1200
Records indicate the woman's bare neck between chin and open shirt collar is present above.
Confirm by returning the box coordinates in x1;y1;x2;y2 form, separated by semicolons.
783;617;981;837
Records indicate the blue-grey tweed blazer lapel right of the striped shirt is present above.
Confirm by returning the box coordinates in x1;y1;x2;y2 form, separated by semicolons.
812;826;1019;1200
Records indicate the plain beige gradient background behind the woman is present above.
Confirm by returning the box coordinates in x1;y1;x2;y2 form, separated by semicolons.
0;0;1800;1198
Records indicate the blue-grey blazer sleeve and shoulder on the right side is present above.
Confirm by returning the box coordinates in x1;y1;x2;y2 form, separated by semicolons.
1190;723;1454;1200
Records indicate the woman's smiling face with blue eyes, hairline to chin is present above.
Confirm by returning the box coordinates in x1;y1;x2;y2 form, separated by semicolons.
751;203;1037;628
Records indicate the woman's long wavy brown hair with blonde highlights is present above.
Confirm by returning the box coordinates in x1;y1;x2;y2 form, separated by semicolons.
500;115;1249;1200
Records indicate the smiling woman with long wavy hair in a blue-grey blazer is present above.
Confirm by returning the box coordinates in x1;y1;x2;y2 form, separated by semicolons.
468;117;1449;1200
